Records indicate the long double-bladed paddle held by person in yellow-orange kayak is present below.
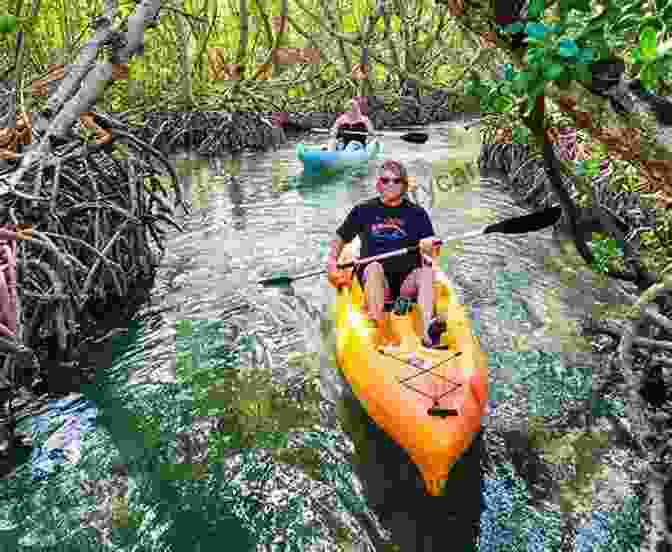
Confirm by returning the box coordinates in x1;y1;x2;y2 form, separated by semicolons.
259;207;562;286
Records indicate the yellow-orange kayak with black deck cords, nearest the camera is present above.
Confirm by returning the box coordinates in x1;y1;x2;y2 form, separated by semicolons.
335;240;488;496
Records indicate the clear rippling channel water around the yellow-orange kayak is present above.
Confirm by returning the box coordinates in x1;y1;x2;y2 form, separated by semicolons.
0;124;639;552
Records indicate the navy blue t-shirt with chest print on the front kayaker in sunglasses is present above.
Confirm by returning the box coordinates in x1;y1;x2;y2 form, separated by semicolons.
336;197;434;287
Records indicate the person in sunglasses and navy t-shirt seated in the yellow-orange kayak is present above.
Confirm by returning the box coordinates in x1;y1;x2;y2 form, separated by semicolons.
327;160;439;347
